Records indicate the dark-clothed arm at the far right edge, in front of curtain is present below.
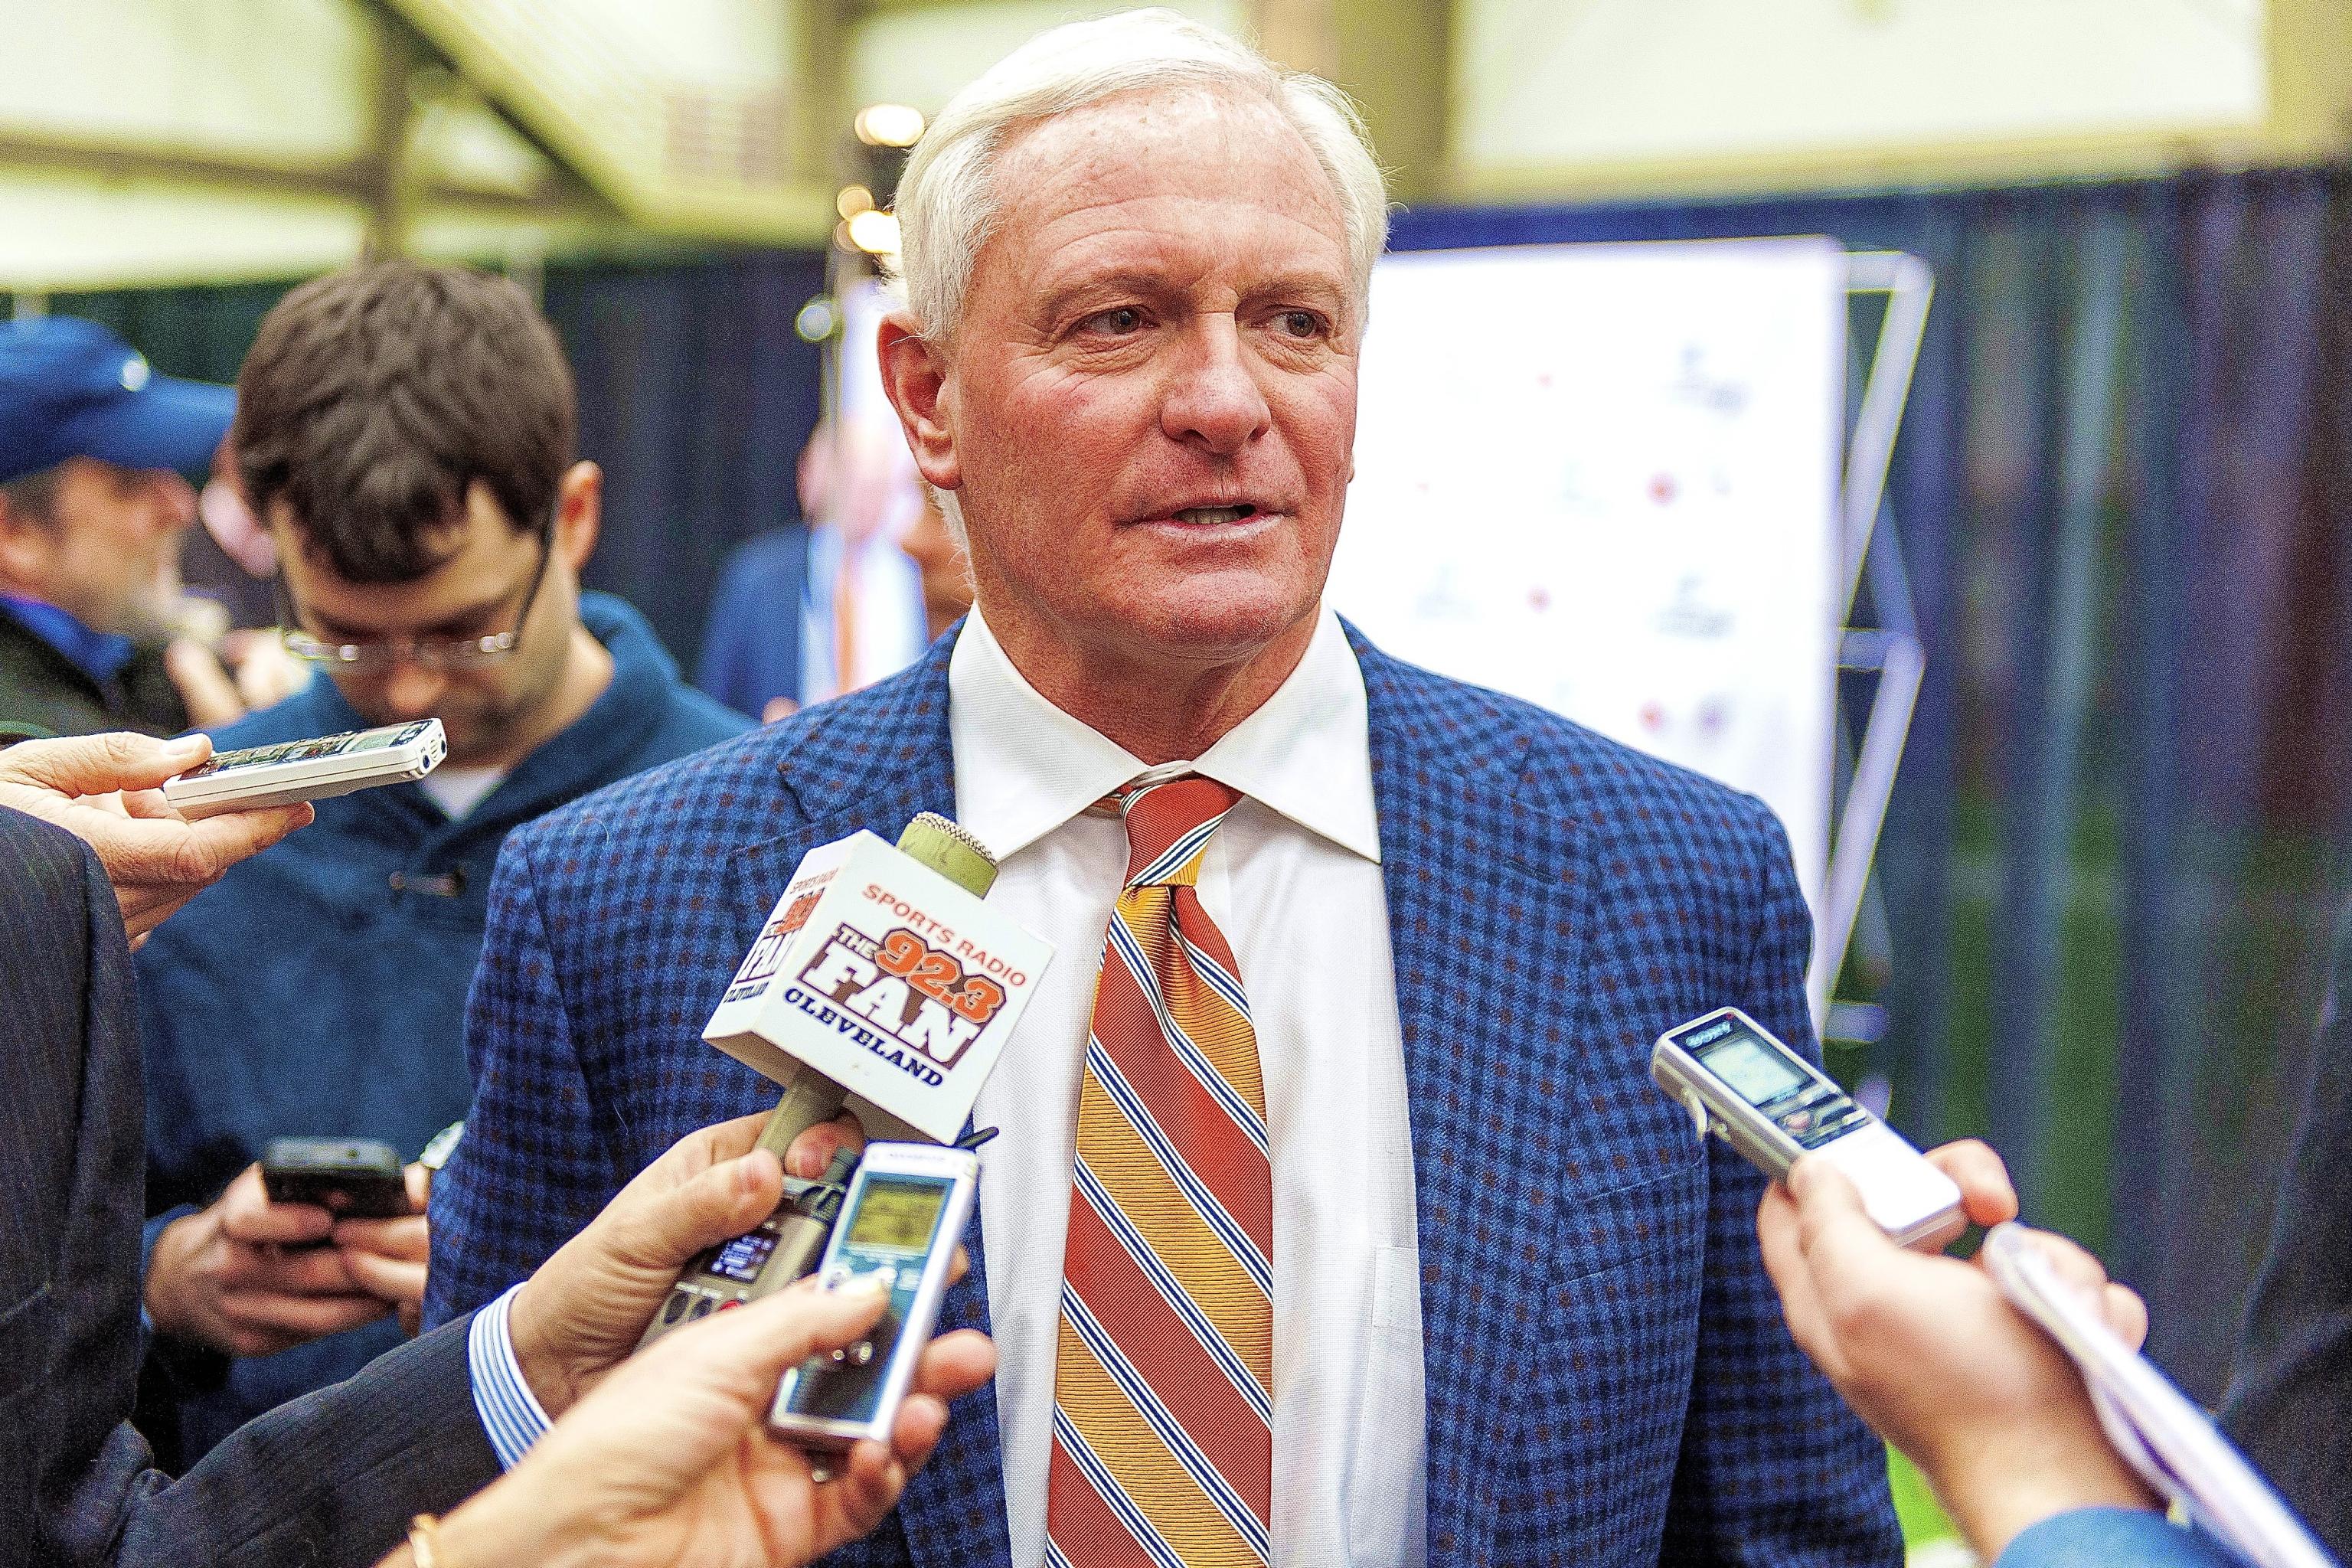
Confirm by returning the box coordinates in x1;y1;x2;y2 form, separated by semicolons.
2223;907;2352;1559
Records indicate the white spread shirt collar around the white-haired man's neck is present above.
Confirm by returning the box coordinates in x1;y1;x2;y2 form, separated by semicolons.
948;609;1380;861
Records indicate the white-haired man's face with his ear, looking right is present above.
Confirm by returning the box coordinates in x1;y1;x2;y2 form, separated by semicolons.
884;92;1360;695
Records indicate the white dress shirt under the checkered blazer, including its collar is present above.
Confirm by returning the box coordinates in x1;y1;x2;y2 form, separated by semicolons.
948;609;1426;1568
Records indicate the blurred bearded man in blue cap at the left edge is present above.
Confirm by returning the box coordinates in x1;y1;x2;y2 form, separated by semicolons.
0;318;237;736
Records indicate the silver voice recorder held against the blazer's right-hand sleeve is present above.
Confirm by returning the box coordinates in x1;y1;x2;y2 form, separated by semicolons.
1648;1006;1968;1250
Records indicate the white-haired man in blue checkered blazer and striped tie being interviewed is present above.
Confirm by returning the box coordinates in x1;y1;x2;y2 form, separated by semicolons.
428;11;1900;1568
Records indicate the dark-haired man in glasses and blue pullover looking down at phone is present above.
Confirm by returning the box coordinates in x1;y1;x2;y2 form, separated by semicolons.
139;263;748;1465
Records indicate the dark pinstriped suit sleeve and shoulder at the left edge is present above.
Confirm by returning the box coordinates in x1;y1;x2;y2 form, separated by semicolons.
0;811;496;1568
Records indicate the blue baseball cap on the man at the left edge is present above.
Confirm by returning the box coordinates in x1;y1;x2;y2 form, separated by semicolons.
0;315;237;485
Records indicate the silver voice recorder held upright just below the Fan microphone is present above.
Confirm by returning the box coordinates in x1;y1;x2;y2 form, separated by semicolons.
769;1142;981;1448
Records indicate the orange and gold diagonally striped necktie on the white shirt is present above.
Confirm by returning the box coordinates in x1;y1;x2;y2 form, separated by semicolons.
1044;773;1275;1568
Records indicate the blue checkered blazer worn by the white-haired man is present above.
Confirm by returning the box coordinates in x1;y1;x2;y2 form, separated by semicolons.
426;632;1903;1568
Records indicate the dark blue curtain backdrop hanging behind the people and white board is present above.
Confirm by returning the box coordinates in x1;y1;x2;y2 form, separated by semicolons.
52;172;2352;1399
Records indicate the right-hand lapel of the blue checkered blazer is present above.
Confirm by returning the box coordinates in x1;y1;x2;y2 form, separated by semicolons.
1348;628;1592;1561
